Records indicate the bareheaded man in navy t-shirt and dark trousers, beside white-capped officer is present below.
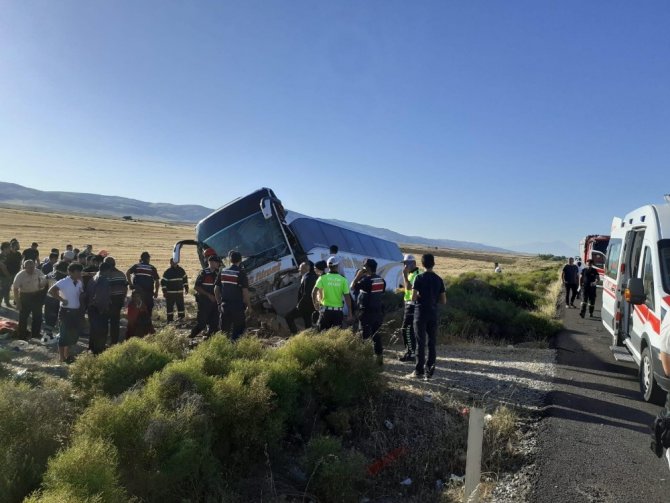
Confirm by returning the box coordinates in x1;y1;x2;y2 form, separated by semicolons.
412;253;447;379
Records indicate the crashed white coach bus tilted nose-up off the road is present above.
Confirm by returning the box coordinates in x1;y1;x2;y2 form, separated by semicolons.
173;188;402;316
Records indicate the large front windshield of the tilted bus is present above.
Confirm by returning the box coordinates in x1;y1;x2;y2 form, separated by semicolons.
199;211;290;271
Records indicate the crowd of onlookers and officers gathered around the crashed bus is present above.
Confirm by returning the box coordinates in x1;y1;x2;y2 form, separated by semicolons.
0;239;446;378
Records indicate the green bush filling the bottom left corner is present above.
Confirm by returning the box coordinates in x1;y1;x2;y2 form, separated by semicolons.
0;381;75;502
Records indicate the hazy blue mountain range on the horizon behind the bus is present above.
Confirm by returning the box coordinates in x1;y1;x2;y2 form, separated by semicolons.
0;182;520;253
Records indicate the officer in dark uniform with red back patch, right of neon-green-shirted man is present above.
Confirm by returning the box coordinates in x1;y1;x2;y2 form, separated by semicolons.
351;258;386;365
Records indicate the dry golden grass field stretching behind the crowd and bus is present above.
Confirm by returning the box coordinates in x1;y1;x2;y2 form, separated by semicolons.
0;208;546;281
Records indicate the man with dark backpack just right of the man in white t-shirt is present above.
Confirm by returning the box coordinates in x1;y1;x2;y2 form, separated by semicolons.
86;262;112;355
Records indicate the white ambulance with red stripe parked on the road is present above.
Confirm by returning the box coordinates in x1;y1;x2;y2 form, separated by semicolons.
602;201;670;403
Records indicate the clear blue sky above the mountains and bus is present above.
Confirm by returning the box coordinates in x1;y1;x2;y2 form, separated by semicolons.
0;0;670;252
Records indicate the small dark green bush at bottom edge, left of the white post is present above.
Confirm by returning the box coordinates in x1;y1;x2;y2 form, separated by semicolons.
304;436;366;503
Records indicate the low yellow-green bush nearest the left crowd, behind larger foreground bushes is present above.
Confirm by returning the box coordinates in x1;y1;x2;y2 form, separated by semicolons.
70;338;174;398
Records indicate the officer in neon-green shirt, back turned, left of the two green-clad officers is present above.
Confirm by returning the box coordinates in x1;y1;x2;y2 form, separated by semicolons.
312;256;353;332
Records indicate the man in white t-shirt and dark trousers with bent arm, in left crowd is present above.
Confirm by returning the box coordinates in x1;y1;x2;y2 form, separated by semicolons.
49;263;84;363
